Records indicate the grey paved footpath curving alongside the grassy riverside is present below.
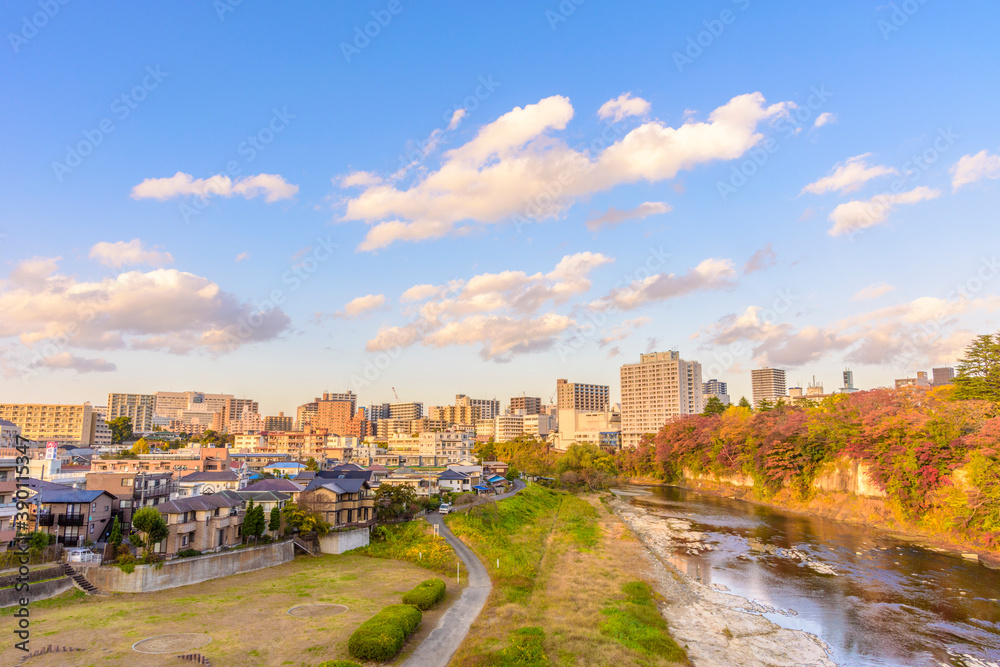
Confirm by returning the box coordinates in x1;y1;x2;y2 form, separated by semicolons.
403;480;525;667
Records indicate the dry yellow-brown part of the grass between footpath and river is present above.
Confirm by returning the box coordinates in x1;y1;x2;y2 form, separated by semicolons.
451;496;676;667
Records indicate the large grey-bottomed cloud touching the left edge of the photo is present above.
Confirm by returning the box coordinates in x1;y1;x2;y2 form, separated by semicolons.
0;260;289;354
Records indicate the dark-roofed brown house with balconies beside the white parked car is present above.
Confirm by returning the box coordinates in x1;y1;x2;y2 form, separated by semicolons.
32;489;115;547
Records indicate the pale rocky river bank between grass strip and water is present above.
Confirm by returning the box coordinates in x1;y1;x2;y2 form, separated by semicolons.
610;491;836;667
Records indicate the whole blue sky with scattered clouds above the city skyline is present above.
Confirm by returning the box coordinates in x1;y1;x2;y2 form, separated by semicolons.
0;0;1000;414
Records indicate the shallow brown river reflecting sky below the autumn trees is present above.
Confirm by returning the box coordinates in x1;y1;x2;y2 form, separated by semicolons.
631;487;1000;667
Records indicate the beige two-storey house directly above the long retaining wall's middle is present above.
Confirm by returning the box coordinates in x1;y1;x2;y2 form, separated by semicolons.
154;493;244;557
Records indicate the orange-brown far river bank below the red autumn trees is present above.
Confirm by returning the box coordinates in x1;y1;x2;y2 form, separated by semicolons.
629;478;1000;570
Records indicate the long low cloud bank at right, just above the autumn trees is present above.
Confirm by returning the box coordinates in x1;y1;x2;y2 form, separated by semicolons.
695;296;1000;368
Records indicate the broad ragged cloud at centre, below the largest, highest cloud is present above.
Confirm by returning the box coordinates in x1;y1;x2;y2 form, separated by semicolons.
366;252;612;362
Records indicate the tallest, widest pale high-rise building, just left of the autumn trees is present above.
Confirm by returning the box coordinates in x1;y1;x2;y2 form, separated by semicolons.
621;351;705;447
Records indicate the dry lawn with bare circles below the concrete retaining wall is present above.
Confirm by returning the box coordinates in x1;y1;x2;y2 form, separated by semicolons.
0;554;460;667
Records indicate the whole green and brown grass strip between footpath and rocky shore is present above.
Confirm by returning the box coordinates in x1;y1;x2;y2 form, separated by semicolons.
448;486;687;667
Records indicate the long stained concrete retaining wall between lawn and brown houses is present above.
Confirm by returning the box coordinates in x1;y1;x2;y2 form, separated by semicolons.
83;541;295;593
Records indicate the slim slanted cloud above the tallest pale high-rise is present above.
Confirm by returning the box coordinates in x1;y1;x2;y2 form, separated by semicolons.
590;258;736;310
